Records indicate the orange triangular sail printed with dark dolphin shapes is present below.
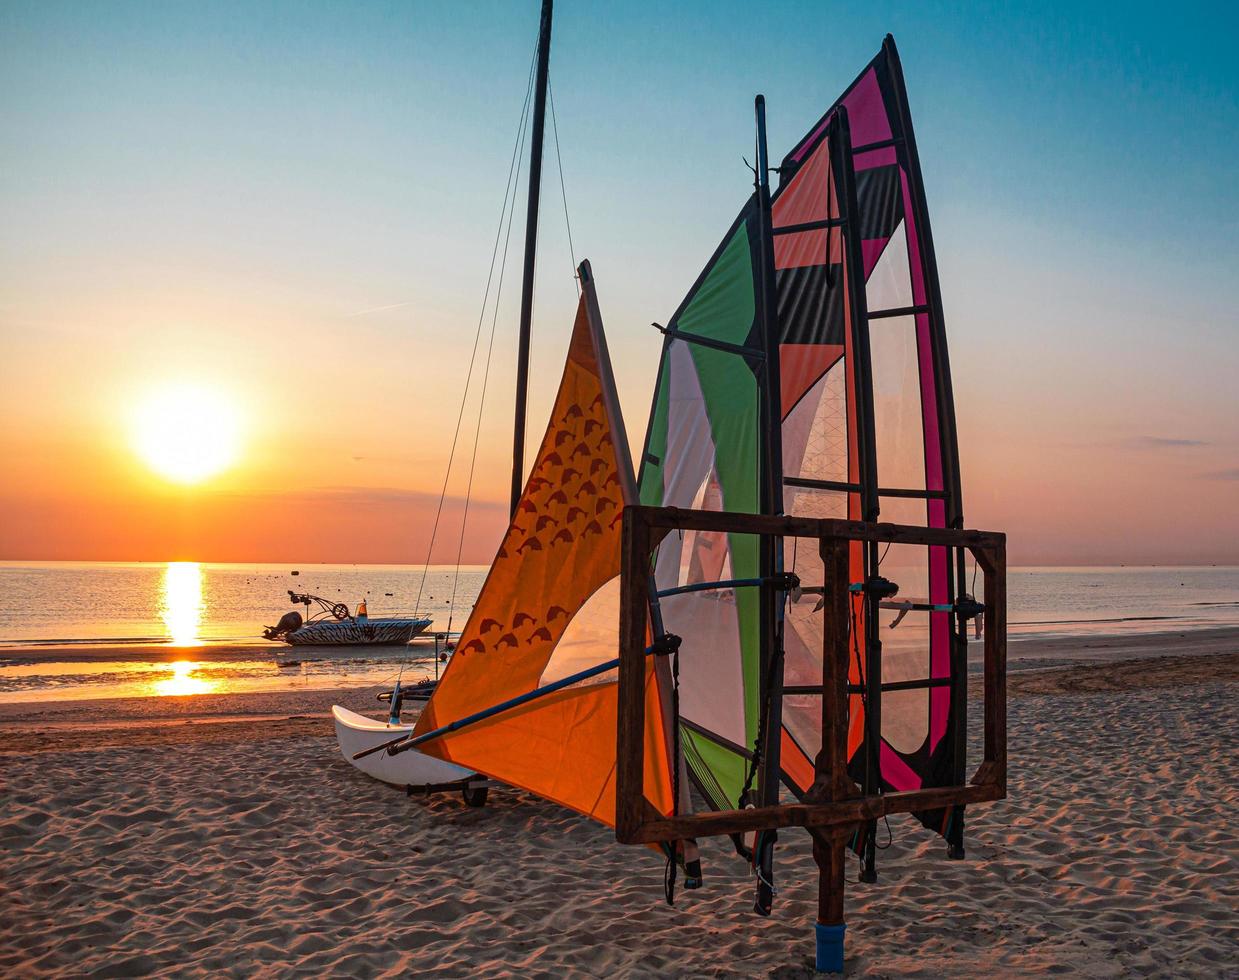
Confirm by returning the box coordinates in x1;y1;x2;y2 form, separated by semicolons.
415;264;673;826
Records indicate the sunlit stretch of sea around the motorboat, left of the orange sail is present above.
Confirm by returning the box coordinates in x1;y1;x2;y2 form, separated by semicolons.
0;561;486;702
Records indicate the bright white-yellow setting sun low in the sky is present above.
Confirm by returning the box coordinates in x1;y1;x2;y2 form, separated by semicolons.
133;384;239;483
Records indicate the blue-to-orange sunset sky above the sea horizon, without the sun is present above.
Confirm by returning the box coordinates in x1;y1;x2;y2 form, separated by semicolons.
0;0;1239;565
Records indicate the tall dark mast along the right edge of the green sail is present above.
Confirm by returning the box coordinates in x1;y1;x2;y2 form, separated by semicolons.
753;95;783;916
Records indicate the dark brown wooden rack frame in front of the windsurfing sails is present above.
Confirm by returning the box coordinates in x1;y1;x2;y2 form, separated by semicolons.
616;507;1006;842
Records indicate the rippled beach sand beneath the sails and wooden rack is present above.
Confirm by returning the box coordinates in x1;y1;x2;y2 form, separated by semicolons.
0;644;1239;978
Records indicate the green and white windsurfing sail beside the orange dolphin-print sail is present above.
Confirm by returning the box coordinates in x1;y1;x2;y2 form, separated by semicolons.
639;202;760;808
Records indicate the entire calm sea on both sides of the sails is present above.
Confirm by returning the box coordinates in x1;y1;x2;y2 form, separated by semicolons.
0;561;1239;701
